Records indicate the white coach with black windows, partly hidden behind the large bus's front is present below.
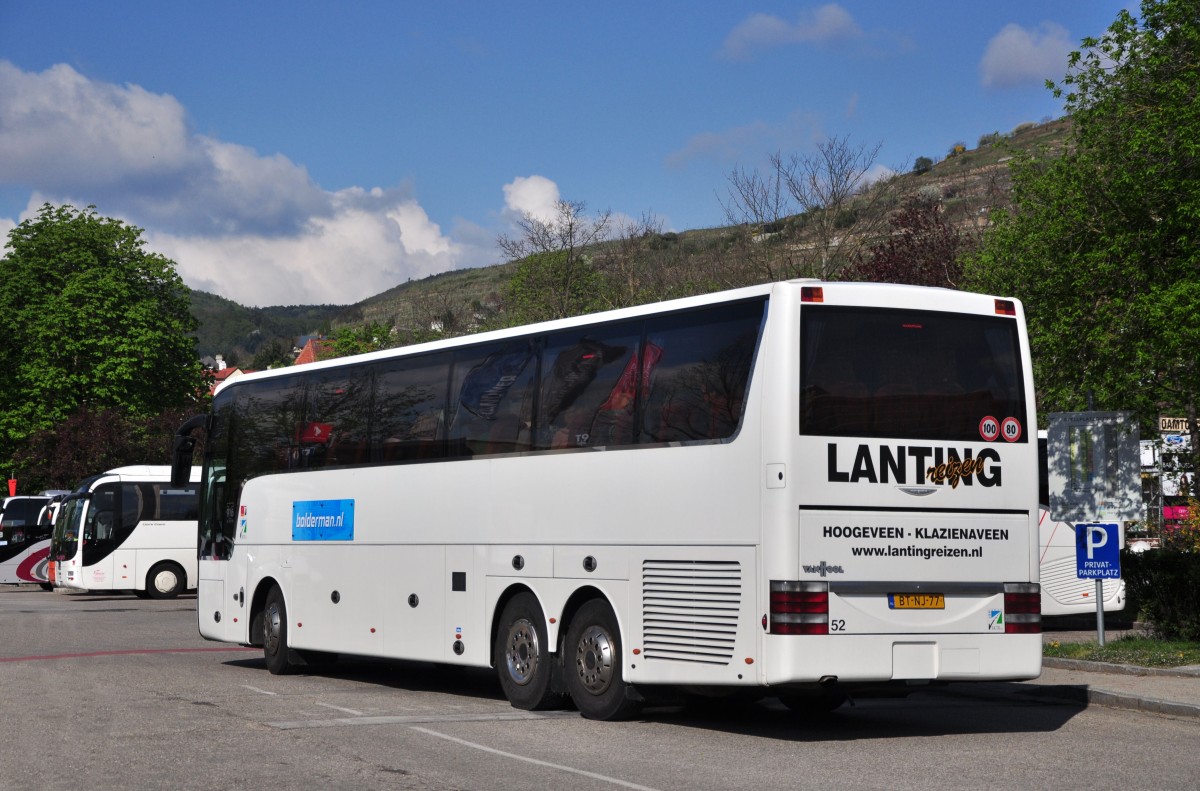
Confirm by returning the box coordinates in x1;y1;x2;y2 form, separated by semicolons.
50;466;200;599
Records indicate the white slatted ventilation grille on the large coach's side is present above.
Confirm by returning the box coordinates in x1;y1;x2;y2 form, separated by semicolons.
642;561;742;665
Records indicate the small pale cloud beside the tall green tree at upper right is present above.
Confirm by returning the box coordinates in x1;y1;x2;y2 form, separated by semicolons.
979;22;1074;88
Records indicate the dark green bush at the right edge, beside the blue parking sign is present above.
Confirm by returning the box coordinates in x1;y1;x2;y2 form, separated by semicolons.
1121;549;1200;641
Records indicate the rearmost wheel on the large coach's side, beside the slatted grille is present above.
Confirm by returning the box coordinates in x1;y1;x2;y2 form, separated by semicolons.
563;599;642;720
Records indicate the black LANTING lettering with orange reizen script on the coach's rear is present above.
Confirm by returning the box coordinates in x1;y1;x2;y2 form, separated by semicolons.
828;443;1001;489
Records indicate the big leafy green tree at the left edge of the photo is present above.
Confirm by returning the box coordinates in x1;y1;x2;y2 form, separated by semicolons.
0;204;204;472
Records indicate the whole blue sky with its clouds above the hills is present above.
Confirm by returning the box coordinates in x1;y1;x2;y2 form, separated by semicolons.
0;0;1135;306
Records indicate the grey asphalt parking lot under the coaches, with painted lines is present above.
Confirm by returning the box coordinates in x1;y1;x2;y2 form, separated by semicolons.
0;587;1200;791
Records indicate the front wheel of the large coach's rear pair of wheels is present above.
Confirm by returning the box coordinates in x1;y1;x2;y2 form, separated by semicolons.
492;593;566;712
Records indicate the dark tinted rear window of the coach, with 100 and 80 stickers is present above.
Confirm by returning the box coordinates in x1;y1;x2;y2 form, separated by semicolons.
800;305;1028;442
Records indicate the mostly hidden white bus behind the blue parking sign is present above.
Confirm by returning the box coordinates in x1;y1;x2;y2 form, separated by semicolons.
1038;431;1126;616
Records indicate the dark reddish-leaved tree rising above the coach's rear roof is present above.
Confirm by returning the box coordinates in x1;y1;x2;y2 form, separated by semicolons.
842;194;973;288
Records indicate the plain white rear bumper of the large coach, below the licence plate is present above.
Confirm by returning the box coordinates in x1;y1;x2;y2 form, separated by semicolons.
763;634;1042;685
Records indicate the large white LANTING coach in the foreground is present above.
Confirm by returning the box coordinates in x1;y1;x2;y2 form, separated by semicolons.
175;281;1042;719
